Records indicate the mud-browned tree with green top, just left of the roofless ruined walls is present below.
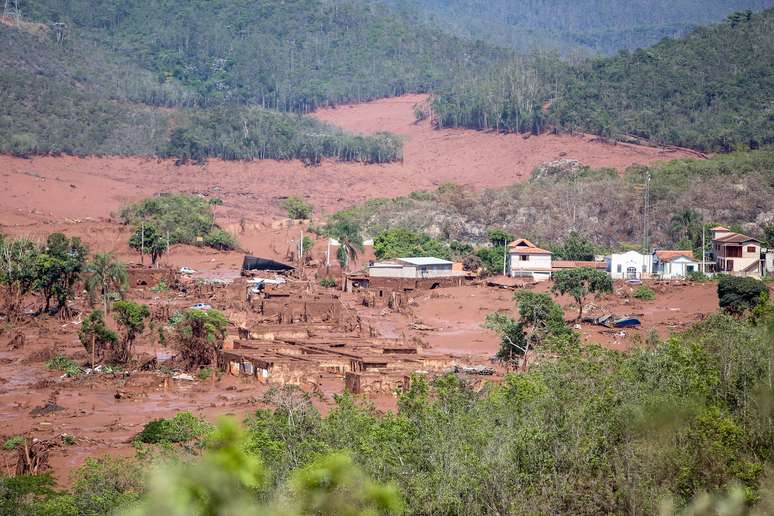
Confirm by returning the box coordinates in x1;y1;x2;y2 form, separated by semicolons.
175;308;228;369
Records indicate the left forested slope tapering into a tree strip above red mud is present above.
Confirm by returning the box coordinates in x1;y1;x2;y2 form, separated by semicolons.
0;18;402;163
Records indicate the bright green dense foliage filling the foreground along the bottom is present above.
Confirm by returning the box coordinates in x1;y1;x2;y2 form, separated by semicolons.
6;312;774;516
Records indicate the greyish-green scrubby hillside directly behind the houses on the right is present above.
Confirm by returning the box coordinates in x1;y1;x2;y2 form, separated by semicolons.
332;148;774;251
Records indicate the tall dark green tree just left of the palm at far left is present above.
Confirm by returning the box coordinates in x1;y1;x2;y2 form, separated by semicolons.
35;233;88;312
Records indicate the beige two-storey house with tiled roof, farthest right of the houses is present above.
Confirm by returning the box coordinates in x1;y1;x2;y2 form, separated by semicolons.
712;226;761;278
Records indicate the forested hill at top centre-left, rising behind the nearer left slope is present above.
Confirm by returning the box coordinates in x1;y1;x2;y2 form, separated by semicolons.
22;0;505;112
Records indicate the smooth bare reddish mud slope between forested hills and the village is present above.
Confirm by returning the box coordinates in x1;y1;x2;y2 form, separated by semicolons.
0;95;690;225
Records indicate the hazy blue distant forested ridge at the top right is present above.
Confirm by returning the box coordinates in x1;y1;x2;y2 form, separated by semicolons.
386;0;774;54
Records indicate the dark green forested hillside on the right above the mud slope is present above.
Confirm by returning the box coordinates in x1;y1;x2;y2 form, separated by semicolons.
433;10;774;151
